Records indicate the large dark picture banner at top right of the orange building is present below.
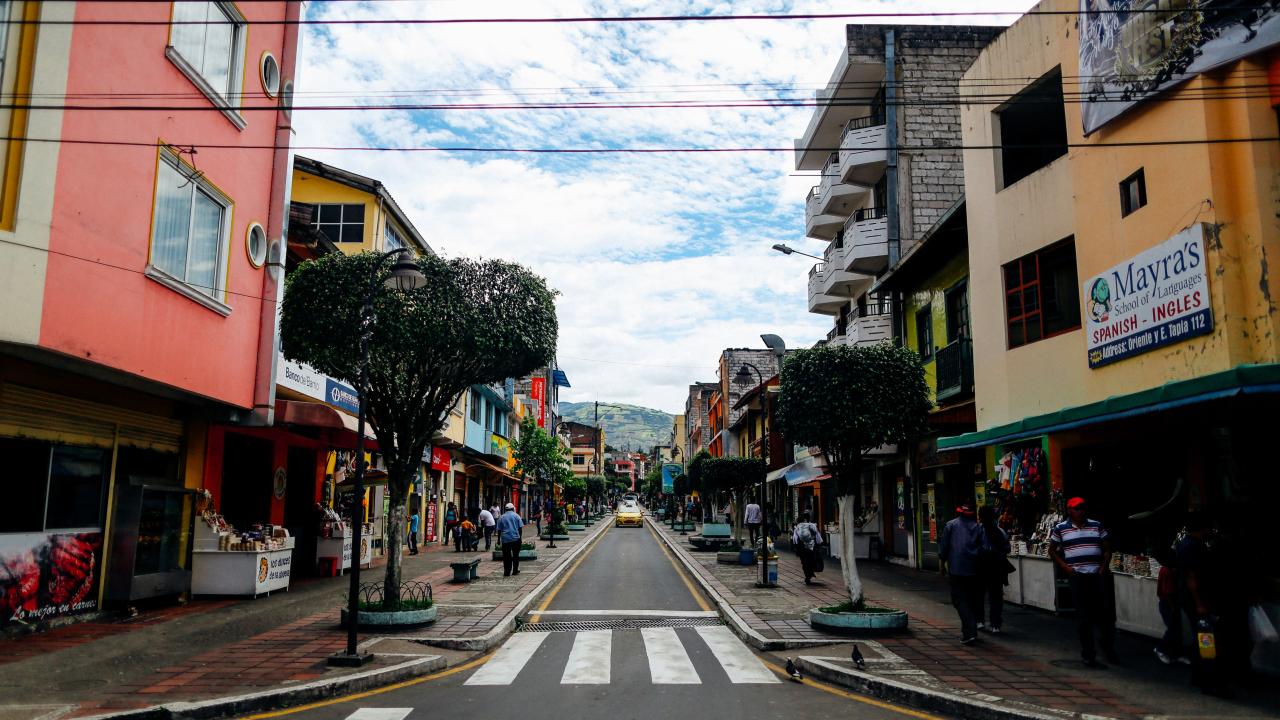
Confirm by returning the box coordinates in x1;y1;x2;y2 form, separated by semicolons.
1079;0;1280;135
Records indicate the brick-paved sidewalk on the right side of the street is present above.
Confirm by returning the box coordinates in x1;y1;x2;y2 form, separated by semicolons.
654;515;1280;717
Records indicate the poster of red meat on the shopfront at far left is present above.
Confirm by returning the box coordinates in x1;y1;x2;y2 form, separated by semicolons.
0;532;102;626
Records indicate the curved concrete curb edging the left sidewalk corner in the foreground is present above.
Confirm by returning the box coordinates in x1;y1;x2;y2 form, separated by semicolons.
81;655;448;720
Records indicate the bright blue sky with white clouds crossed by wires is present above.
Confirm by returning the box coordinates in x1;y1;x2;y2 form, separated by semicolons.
294;0;1032;413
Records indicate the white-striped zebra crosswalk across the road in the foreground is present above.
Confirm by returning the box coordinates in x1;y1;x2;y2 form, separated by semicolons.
460;625;780;681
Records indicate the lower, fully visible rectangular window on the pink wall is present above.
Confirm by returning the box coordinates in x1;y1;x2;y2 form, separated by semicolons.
147;149;232;308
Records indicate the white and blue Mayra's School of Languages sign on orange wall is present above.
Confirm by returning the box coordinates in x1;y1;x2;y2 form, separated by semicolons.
1084;224;1213;368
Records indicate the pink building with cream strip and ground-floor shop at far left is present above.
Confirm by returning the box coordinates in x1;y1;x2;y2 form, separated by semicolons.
0;1;301;625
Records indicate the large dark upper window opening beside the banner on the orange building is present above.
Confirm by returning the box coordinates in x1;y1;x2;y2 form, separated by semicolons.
992;69;1066;188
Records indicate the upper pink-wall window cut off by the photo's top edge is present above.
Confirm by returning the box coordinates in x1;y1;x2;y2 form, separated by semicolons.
169;0;246;108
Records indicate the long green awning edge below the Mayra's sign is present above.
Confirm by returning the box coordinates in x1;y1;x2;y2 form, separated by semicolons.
938;364;1280;450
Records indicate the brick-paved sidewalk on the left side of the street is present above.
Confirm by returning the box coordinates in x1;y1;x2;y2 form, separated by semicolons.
0;523;604;720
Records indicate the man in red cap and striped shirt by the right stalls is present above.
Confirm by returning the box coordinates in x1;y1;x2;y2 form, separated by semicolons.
1048;497;1120;667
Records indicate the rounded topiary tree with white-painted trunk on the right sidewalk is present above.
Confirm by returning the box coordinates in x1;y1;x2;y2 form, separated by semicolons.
777;342;933;609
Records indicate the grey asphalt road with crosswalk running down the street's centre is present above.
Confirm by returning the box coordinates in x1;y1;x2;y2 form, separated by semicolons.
264;509;923;720
